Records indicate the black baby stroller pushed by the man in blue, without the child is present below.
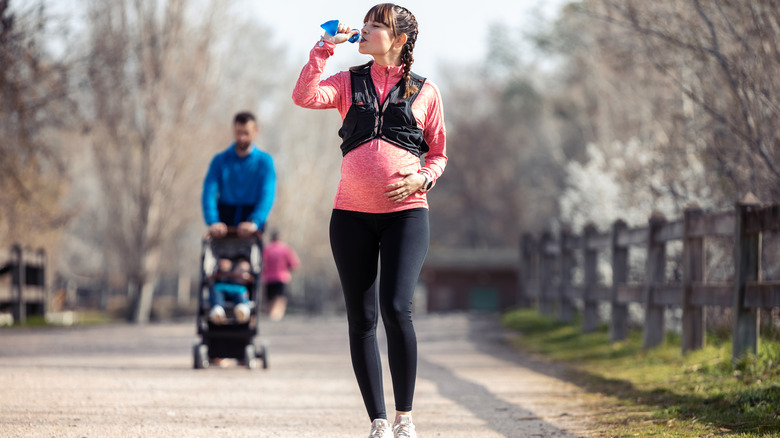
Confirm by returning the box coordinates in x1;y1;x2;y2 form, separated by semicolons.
192;228;268;369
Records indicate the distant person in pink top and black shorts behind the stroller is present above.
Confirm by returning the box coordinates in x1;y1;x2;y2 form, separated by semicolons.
262;231;301;321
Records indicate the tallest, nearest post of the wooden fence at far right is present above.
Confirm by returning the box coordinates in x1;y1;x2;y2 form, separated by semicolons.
732;193;761;360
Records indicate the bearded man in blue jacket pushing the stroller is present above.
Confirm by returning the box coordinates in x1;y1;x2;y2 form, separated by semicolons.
201;111;276;237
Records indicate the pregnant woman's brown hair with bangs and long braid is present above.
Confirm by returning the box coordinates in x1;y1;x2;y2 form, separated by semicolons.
356;3;417;97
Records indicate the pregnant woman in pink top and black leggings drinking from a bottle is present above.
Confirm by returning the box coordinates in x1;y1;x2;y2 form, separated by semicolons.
292;3;447;438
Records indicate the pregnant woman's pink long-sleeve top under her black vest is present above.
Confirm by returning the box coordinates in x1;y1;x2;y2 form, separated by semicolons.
293;41;447;213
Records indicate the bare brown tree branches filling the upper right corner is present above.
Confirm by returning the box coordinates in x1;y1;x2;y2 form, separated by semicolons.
586;0;780;201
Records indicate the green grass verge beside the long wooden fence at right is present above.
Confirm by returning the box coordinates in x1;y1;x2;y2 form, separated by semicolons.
503;309;780;437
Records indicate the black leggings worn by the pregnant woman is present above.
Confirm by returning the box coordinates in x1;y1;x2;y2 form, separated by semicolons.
330;208;430;420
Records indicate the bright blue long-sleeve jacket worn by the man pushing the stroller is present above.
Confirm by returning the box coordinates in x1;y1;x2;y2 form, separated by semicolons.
201;143;276;230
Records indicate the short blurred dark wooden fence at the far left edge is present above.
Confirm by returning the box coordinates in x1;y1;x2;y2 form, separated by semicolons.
0;245;46;323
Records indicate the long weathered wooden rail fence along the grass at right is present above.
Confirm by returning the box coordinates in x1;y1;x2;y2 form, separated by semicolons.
519;194;780;359
